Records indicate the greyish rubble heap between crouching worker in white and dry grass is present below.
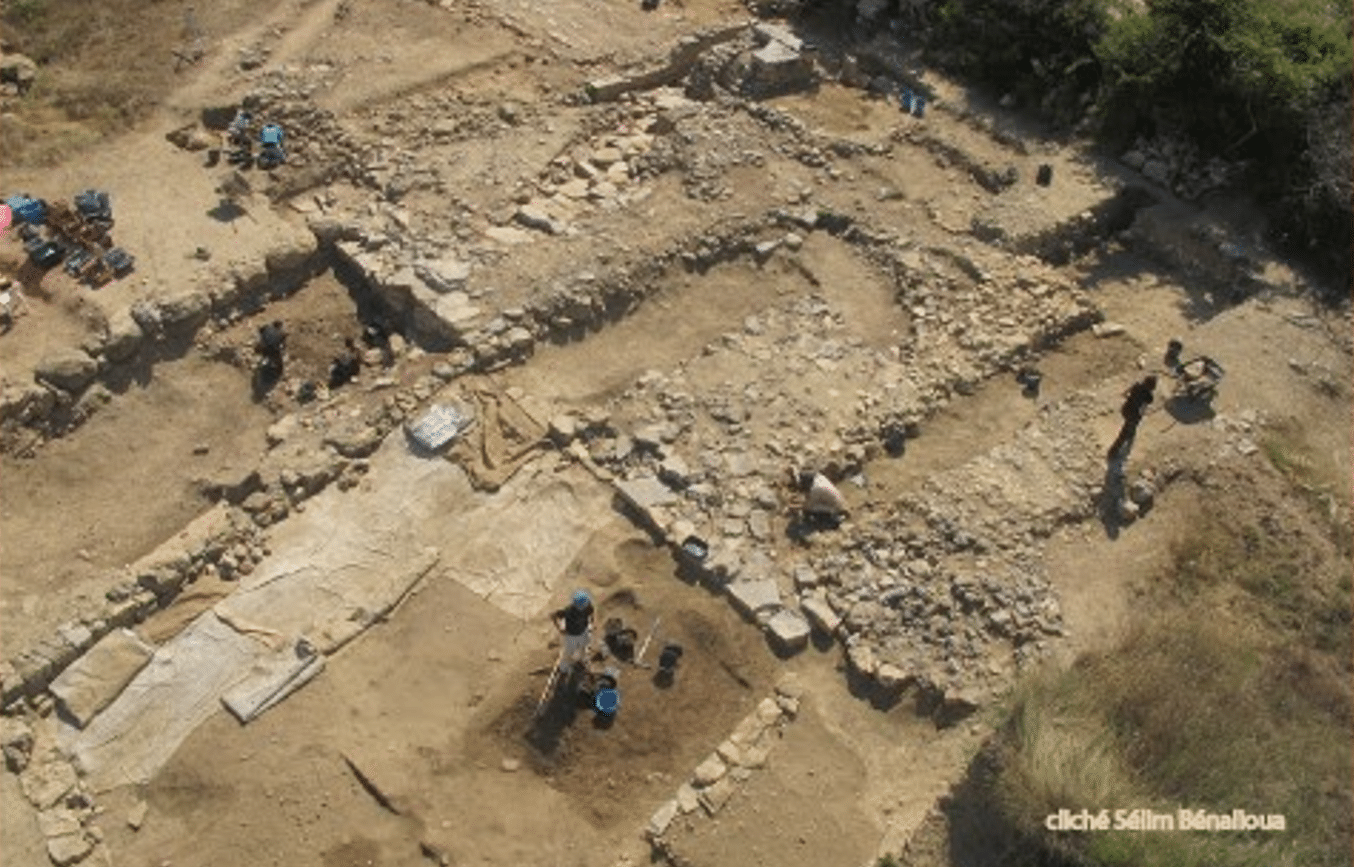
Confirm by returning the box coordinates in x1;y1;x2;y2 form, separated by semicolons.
795;396;1110;703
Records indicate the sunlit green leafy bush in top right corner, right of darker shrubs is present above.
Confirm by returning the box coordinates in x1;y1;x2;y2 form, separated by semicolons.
1095;0;1354;286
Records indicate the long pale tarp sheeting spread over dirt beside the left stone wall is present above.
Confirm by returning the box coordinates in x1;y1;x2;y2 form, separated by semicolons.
54;422;613;791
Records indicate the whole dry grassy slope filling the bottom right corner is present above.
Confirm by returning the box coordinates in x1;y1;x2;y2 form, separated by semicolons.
994;466;1354;867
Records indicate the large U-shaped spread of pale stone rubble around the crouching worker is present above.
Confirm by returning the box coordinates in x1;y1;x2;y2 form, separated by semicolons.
533;224;1099;715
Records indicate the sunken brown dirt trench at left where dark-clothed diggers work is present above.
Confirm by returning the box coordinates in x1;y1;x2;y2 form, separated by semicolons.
0;254;389;654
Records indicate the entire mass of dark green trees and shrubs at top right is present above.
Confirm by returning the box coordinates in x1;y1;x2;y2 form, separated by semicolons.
927;0;1354;283
